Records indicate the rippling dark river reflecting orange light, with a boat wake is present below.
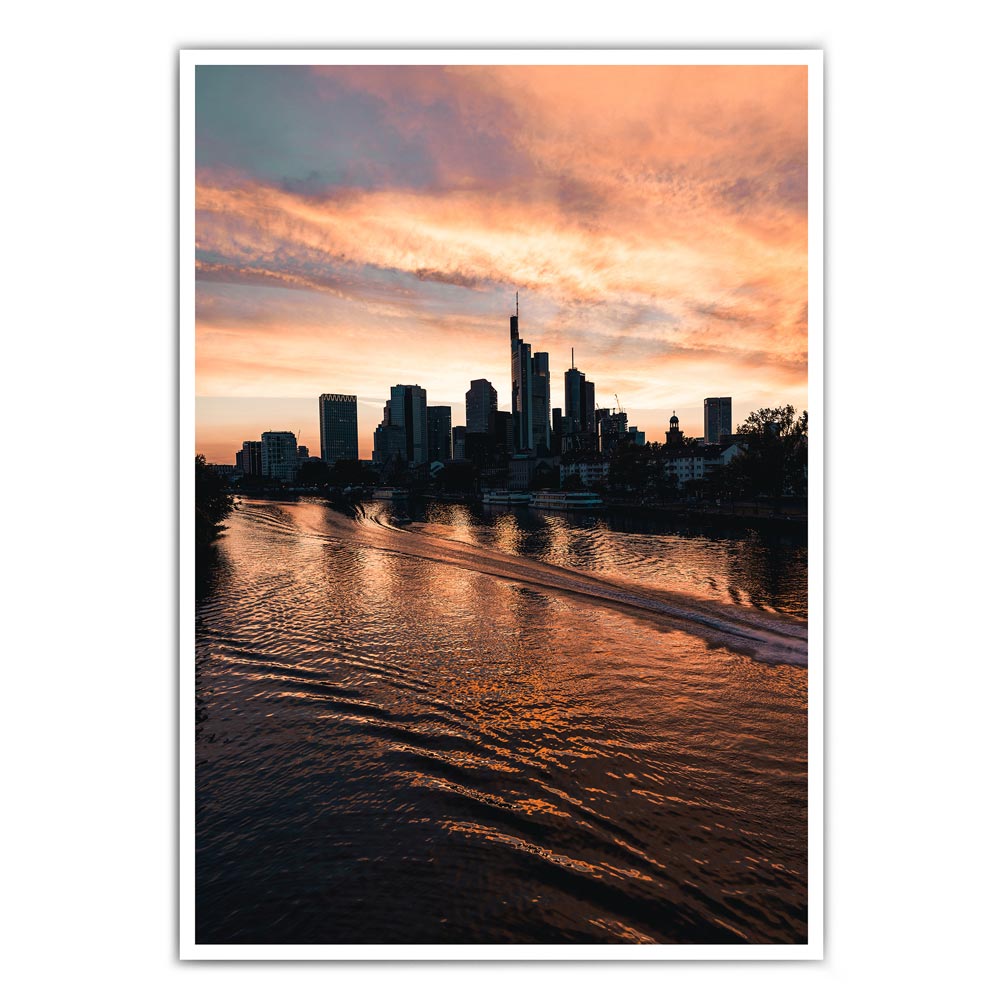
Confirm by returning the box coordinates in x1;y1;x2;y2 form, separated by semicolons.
196;500;807;944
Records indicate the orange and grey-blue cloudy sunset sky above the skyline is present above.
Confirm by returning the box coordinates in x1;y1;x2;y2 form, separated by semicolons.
196;66;807;463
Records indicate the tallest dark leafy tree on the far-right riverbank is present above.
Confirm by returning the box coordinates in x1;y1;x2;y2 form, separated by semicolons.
729;404;809;502
